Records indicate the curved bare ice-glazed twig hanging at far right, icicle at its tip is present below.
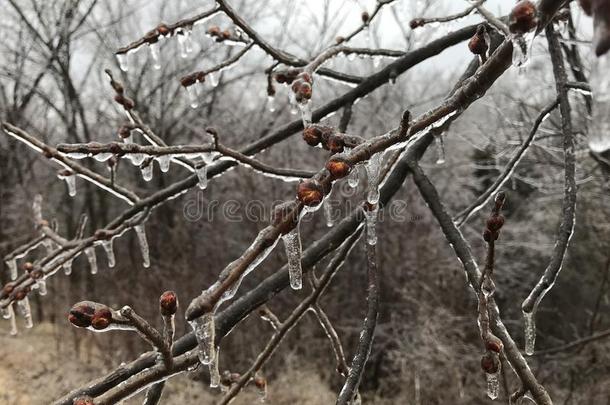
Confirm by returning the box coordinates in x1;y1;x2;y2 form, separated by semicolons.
521;25;576;354
